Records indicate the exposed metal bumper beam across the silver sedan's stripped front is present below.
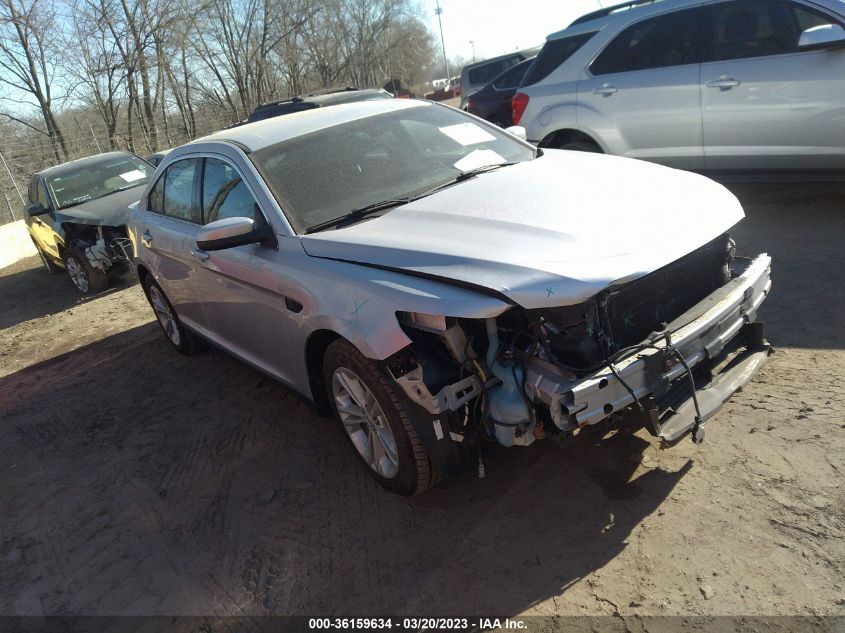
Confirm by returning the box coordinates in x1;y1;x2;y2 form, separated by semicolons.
526;254;771;442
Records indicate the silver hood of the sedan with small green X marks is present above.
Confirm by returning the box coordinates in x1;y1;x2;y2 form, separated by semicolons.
302;150;744;308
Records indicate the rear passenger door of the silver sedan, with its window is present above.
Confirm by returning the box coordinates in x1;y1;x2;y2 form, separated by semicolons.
137;158;207;331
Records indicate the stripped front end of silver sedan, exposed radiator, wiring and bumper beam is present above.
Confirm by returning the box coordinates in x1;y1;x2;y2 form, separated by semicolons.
387;234;771;446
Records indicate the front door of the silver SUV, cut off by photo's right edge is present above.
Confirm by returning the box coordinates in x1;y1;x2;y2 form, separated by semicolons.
701;0;845;170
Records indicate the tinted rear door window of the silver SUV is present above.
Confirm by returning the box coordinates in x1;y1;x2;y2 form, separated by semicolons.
590;7;704;75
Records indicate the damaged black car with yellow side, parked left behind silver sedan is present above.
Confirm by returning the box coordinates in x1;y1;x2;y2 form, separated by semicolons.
25;152;155;292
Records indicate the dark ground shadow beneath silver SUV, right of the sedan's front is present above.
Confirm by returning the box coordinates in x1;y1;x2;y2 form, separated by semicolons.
728;183;845;349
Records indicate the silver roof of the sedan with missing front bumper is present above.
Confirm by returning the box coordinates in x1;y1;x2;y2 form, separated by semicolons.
188;99;434;152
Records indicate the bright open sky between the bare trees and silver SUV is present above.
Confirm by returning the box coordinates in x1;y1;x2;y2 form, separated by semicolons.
420;0;604;59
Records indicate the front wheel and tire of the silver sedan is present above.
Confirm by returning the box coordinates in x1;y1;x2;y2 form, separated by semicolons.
323;339;432;497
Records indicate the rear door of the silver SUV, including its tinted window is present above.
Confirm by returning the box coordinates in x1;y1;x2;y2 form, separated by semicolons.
578;8;704;169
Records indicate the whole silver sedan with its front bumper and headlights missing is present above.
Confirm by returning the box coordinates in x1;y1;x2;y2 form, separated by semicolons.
129;100;770;495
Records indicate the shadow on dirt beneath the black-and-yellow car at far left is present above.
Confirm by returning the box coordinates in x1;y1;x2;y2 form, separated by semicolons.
0;255;136;330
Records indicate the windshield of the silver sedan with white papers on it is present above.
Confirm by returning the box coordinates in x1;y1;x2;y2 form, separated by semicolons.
250;105;534;232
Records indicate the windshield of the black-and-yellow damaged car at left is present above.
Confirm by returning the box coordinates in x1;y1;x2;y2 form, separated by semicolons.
47;155;155;209
